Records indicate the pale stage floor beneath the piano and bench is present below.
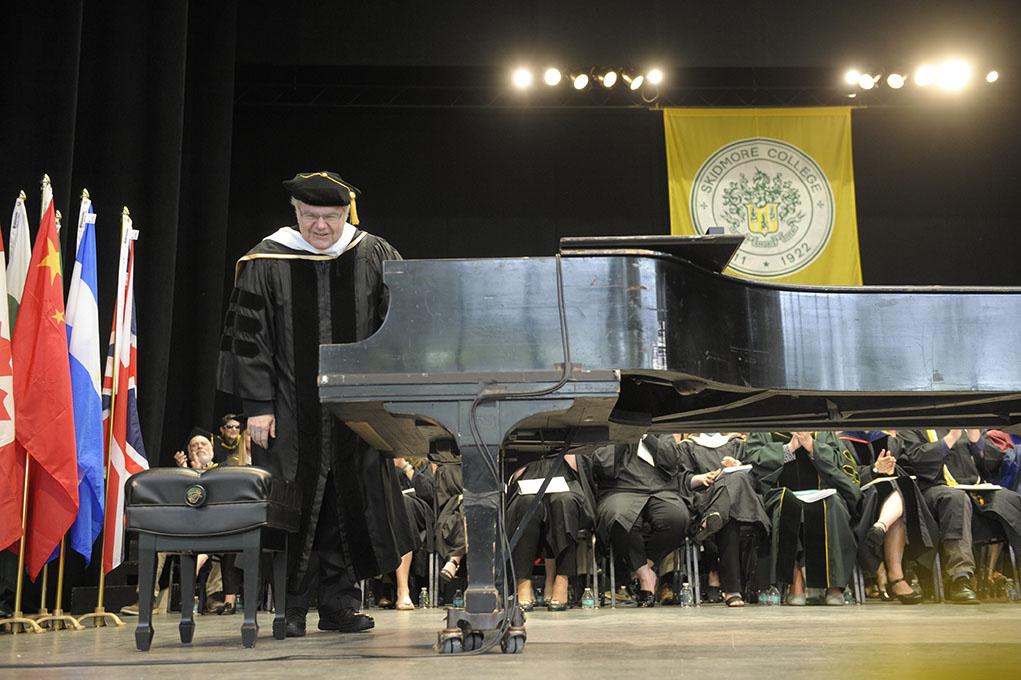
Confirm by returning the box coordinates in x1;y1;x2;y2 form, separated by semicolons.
0;602;1021;680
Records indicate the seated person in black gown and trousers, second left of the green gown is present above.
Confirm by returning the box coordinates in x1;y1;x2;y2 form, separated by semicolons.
578;435;691;606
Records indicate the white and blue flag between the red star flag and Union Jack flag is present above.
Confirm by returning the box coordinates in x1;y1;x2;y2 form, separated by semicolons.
65;198;104;564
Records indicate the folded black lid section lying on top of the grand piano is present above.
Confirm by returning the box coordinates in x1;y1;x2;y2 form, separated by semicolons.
561;235;744;274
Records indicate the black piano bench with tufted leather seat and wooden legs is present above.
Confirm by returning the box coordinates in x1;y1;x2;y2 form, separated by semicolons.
125;467;301;651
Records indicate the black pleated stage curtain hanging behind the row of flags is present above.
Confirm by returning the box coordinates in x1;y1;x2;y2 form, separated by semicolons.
0;0;237;464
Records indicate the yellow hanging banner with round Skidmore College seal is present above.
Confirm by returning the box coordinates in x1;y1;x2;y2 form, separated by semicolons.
664;106;862;286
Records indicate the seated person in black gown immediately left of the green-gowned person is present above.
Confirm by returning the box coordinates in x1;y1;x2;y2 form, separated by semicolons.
678;433;770;606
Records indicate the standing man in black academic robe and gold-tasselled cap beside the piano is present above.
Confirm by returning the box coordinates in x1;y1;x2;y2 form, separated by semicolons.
217;172;414;636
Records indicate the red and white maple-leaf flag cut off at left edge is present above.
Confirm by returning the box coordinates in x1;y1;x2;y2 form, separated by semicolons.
0;219;25;549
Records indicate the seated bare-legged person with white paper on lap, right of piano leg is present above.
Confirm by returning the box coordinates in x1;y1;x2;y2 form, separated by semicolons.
506;453;595;612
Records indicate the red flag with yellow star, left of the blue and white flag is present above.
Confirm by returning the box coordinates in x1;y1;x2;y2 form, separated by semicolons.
12;195;78;579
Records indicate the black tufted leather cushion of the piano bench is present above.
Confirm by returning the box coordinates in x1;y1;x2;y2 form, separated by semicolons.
125;466;301;536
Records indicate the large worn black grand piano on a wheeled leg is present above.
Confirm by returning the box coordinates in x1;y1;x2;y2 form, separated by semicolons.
320;236;1021;651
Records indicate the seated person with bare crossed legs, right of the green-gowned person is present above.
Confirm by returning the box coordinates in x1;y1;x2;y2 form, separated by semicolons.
840;431;937;604
